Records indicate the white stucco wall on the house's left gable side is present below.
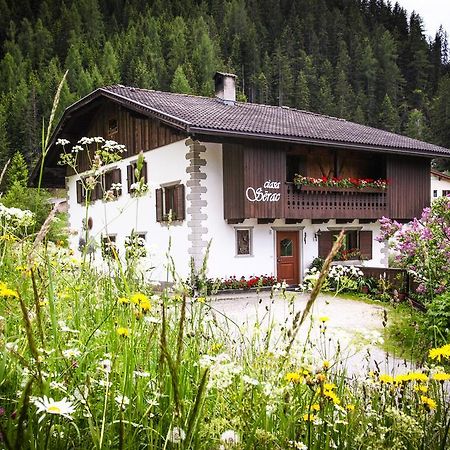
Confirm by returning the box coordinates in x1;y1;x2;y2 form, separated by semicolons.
67;140;189;280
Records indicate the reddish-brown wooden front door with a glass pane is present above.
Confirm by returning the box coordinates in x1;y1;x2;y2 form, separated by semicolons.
277;231;300;284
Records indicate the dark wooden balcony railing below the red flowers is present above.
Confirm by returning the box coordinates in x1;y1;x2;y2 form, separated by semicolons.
284;183;388;219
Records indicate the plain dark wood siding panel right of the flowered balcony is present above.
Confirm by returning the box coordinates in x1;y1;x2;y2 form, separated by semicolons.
387;155;431;219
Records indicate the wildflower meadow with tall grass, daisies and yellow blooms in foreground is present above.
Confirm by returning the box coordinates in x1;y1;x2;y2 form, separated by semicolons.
0;207;450;450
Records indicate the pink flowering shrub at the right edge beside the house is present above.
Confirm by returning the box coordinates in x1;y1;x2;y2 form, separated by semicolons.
377;196;450;302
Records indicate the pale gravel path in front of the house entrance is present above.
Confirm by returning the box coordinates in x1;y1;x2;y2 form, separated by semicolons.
212;292;410;374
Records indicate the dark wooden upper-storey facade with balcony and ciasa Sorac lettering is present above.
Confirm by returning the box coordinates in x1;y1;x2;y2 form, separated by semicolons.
223;141;430;223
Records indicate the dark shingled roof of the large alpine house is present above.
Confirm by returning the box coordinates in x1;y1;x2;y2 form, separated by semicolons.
59;85;450;157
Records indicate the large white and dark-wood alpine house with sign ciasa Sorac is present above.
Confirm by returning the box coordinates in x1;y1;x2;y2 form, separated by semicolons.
35;73;450;284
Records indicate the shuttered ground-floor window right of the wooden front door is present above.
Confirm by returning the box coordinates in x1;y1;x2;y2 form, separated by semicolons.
318;230;372;261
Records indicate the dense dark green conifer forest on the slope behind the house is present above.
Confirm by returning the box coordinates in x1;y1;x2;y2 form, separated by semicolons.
0;0;450;166
